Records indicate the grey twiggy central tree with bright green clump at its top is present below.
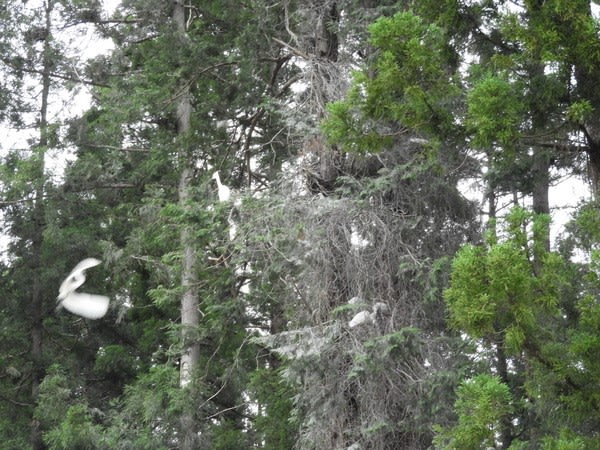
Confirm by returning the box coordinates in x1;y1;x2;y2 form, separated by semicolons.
245;7;472;449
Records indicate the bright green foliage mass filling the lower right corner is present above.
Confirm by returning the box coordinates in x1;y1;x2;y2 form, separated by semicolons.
438;207;600;449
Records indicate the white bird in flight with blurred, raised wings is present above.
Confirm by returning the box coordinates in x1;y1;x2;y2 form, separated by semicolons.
57;258;110;319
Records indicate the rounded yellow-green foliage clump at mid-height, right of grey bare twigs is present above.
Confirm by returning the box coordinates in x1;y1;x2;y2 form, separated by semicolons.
445;209;565;354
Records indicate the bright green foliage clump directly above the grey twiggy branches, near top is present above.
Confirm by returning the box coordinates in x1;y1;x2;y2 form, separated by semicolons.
323;12;456;153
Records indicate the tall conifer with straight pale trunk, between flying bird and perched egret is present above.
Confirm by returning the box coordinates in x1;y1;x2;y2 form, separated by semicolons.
42;2;302;448
